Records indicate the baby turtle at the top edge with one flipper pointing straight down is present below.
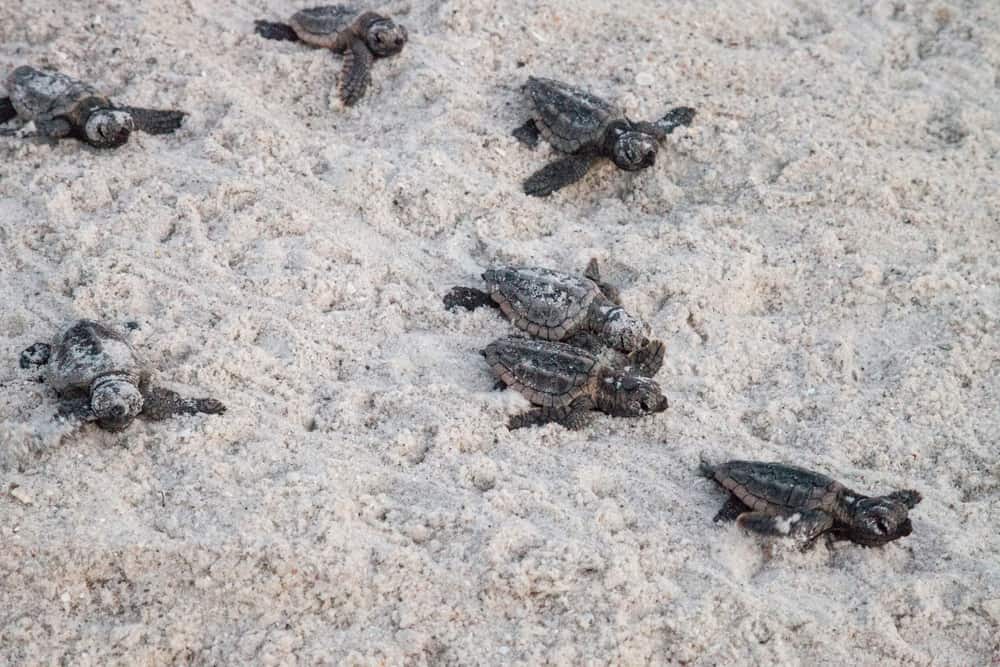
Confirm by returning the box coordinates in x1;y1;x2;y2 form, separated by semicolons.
254;5;409;106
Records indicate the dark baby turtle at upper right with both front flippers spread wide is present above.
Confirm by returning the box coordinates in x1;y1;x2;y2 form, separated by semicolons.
513;77;695;197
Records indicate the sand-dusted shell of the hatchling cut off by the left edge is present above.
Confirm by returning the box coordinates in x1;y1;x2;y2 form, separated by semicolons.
7;65;111;122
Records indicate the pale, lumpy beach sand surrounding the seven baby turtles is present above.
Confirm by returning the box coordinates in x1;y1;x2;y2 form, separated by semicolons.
0;0;1000;665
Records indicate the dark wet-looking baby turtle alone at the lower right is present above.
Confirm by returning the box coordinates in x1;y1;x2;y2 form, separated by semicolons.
700;460;921;547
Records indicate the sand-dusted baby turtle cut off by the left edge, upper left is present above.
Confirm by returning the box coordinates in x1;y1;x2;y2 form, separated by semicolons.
0;65;187;148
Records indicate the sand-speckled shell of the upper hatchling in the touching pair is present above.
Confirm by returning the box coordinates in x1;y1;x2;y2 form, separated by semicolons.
483;266;601;340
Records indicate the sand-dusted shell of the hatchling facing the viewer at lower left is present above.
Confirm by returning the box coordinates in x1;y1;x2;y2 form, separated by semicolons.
49;320;147;394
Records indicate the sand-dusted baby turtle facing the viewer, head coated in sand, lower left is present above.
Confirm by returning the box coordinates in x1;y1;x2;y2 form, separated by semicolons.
21;320;226;431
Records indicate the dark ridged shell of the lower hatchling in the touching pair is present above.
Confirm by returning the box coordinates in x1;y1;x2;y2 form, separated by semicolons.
483;336;598;408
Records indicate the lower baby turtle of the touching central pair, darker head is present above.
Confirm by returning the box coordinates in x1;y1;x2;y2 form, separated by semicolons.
483;336;667;429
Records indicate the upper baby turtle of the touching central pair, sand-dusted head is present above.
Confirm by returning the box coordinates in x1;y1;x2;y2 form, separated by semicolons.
444;259;664;377
